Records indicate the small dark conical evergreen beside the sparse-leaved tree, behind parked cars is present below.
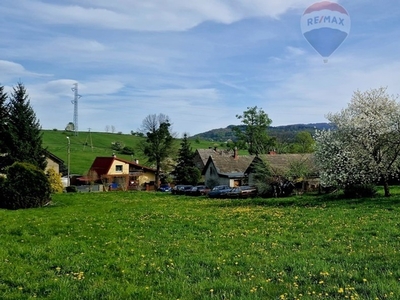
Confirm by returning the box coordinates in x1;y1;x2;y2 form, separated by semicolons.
172;133;201;185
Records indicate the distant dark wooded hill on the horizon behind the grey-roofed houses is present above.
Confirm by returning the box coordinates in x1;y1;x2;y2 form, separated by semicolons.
191;123;332;142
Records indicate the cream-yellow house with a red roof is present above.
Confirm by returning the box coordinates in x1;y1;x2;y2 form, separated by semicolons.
79;156;156;190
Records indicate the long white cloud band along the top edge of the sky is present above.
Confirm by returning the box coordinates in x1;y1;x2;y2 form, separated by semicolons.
15;0;313;31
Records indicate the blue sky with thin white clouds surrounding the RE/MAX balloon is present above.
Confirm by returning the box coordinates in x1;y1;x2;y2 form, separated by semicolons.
0;0;400;135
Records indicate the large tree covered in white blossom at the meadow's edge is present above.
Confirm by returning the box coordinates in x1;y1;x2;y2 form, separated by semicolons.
315;88;400;197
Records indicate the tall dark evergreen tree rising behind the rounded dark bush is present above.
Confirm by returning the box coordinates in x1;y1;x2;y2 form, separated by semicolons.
6;83;47;170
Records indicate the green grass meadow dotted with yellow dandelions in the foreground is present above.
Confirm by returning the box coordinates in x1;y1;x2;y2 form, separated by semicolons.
0;190;400;300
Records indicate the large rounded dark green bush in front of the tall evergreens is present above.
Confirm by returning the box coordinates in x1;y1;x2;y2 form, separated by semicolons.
0;162;51;209
